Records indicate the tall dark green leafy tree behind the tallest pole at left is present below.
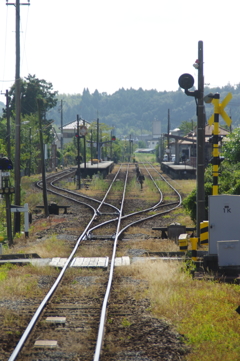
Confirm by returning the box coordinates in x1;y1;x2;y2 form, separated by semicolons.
0;74;57;173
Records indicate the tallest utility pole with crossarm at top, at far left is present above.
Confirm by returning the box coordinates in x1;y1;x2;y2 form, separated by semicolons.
6;0;30;233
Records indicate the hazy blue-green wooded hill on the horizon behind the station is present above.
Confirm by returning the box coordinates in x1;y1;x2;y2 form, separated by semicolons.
46;84;240;135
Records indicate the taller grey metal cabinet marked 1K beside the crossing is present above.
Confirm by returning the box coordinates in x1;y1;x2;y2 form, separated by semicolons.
208;195;240;255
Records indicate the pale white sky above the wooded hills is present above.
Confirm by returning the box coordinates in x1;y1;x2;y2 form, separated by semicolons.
0;0;240;103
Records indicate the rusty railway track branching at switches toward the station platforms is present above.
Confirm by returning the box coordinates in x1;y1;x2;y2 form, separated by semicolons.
3;164;188;361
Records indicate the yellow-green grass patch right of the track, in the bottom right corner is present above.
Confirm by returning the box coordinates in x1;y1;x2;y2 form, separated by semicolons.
116;261;240;361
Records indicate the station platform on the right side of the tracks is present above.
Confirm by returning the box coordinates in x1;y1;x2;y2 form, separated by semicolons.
161;162;196;179
